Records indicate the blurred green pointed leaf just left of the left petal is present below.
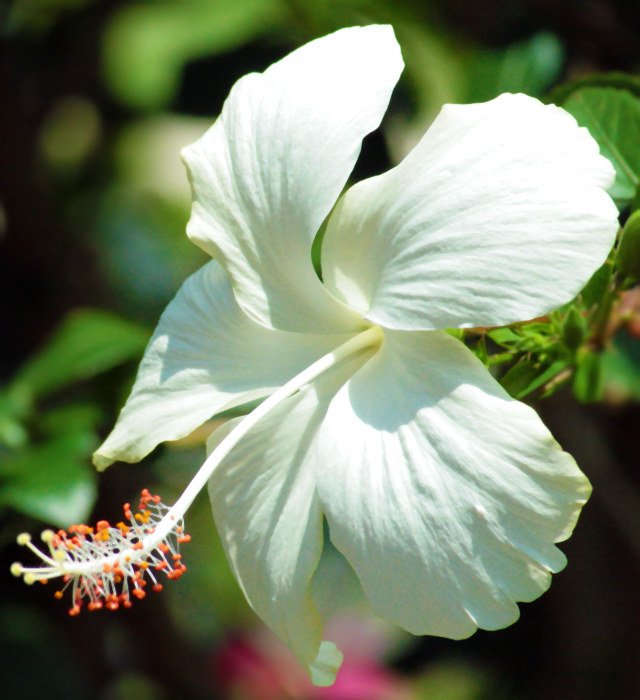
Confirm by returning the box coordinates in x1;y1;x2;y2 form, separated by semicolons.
10;309;149;397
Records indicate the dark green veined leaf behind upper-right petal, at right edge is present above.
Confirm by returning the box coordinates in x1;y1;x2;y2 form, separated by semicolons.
562;87;640;208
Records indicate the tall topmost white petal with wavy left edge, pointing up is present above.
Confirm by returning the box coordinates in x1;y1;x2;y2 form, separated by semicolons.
183;26;403;333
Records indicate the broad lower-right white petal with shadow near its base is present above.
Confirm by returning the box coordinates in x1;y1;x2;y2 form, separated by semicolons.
317;331;591;639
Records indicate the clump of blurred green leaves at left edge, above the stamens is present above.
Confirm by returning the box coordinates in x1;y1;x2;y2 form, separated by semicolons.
0;309;149;527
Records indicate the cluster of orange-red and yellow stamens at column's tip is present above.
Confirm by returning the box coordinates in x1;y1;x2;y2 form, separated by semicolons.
11;489;191;616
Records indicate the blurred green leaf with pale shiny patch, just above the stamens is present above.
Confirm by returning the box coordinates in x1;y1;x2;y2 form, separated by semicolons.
0;430;97;527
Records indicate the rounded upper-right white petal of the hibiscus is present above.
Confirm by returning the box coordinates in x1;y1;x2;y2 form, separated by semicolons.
322;95;618;330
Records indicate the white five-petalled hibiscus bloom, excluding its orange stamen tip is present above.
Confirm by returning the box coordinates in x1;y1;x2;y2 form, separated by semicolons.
20;26;617;684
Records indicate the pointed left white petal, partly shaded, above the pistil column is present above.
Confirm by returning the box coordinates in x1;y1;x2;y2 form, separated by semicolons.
94;260;356;469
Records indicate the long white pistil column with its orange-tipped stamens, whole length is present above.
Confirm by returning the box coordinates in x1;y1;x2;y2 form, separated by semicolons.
11;326;384;615
